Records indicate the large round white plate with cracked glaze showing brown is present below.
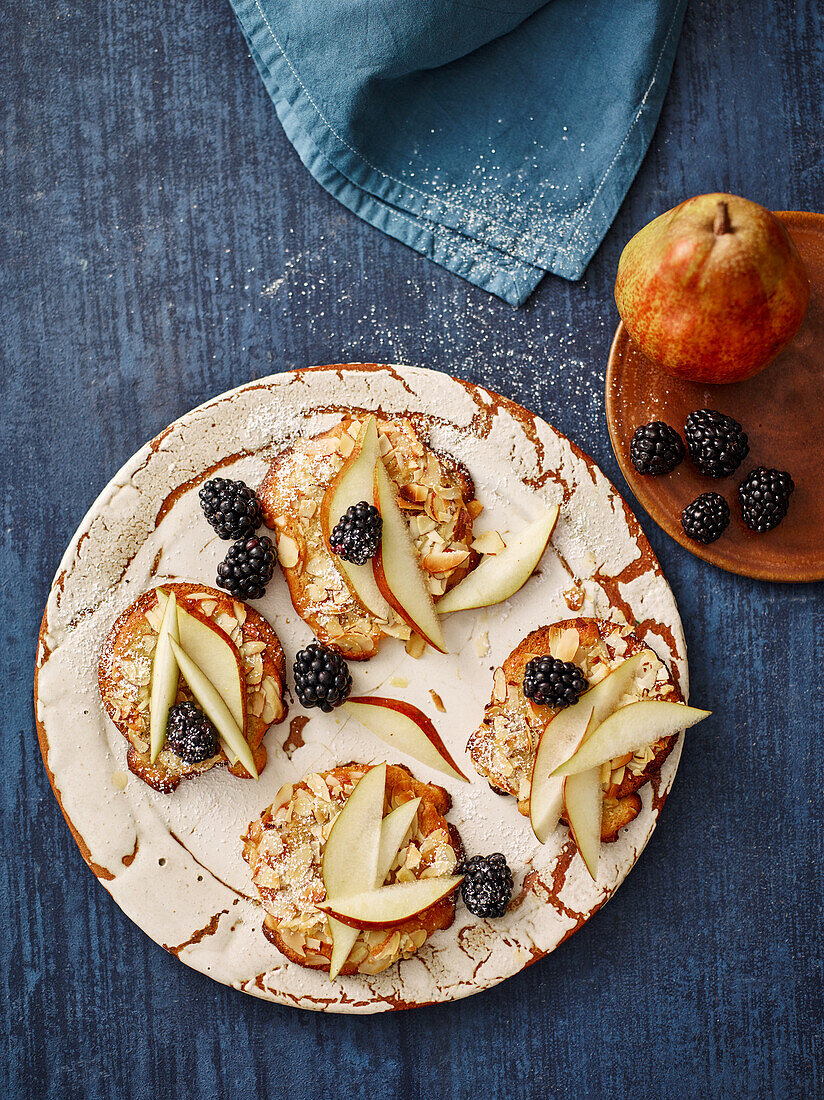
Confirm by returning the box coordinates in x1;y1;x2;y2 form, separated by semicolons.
35;364;688;1012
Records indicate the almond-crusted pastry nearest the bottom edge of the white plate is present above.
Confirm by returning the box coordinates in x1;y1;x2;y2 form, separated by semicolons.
243;763;462;975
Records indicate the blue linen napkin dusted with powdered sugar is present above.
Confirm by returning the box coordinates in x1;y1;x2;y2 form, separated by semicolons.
227;0;686;306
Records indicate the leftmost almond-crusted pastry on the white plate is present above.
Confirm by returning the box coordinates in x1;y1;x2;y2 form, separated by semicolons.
98;583;286;792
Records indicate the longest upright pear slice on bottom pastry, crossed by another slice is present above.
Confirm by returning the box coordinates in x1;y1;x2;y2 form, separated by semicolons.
321;763;385;980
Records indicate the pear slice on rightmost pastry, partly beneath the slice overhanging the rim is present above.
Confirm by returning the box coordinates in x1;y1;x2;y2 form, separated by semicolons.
529;649;657;844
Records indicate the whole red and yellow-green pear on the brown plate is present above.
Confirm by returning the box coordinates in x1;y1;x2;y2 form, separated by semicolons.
615;194;810;383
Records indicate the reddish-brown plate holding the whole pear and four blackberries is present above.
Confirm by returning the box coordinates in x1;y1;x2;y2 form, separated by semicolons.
606;211;824;581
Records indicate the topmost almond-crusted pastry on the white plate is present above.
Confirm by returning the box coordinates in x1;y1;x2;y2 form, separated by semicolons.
257;415;481;660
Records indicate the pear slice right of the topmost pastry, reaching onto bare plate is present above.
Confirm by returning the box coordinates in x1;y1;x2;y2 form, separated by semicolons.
438;505;558;615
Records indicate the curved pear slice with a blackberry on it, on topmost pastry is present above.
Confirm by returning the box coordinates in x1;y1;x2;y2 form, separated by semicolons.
320;416;393;620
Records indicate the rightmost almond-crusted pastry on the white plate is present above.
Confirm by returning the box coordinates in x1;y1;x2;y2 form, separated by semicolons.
466;618;682;840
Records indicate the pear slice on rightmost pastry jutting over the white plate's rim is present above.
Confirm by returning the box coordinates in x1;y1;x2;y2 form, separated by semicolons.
552;700;711;776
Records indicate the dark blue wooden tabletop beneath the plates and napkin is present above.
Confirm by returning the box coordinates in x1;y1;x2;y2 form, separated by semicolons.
0;0;824;1100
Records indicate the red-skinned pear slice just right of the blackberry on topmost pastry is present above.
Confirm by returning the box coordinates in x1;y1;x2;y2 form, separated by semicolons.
372;461;447;653
